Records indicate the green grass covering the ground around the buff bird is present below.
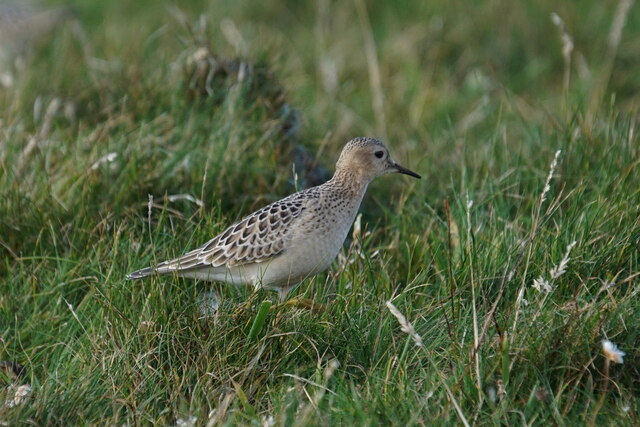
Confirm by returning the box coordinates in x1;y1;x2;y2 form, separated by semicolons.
0;0;640;425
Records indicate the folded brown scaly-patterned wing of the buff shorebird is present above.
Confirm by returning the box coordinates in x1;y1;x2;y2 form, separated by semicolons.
156;193;309;273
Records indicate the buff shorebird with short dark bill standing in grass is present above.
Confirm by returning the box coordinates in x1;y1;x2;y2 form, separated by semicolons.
127;137;421;302
